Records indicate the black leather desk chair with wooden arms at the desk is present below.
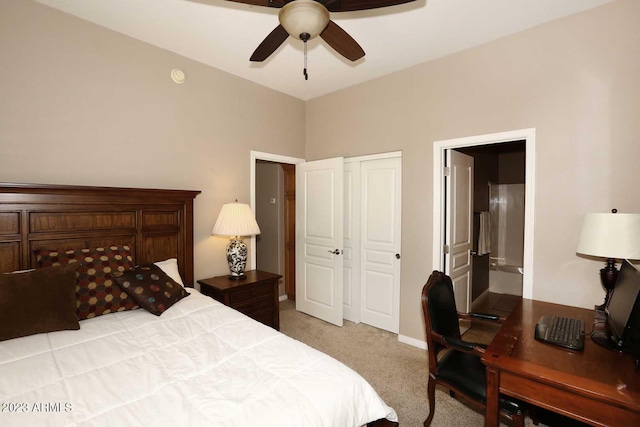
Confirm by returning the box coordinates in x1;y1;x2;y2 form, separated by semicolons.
422;271;524;427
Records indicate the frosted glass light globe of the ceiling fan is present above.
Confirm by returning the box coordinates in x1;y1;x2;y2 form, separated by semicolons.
278;0;329;41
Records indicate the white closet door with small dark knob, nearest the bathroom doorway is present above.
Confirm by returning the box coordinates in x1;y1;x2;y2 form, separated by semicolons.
360;157;402;334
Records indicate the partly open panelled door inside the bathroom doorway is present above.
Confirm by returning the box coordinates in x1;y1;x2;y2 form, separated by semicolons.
444;150;473;312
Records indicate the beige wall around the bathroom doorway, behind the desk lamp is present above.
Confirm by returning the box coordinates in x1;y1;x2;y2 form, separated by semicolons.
305;0;640;340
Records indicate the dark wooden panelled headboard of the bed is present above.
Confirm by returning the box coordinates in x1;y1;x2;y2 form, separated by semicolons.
0;183;200;287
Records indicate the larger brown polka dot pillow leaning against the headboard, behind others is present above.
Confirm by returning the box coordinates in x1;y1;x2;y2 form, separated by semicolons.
34;246;138;320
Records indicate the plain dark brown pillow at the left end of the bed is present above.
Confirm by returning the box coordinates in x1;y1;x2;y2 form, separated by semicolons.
0;264;80;341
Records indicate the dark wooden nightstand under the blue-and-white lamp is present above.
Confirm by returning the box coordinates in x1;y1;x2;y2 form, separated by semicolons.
198;270;282;330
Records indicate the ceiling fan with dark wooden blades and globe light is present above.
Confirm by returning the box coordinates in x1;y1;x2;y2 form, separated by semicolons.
229;0;415;67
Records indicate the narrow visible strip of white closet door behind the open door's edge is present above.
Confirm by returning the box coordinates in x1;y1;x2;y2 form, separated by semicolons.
343;162;361;323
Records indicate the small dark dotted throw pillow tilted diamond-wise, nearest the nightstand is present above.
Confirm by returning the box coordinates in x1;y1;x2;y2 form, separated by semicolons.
114;264;189;316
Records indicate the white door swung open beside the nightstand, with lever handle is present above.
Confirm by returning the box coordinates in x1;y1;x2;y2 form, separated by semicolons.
296;157;344;326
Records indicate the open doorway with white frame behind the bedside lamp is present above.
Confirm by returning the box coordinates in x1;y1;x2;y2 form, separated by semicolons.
249;151;304;300
